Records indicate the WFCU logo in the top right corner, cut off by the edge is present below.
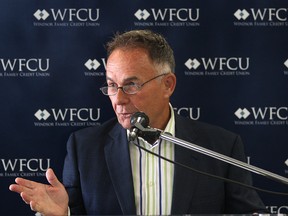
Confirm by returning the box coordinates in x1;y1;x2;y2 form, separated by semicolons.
234;8;288;27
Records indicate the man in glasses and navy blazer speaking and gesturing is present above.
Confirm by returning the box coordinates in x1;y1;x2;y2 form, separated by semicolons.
10;30;265;215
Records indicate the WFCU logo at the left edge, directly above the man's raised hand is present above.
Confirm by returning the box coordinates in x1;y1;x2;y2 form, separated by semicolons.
0;158;50;177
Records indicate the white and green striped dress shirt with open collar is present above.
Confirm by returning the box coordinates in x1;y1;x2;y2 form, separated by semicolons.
129;105;175;215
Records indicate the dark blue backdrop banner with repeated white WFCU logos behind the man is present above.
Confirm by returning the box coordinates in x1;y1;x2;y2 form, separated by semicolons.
0;0;288;215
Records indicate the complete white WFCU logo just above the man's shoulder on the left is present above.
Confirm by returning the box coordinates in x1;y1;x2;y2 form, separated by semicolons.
34;108;101;127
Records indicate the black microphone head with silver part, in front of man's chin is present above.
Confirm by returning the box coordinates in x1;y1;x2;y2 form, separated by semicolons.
130;112;149;140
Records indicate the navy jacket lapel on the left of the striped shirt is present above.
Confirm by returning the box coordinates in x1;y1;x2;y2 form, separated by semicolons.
105;124;136;215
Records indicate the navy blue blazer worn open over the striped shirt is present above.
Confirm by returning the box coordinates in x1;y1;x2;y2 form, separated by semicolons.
63;115;265;215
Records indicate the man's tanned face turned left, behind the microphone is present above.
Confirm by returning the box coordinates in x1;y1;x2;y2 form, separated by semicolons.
106;48;174;129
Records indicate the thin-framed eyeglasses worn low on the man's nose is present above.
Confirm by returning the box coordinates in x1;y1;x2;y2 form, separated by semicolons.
100;73;168;96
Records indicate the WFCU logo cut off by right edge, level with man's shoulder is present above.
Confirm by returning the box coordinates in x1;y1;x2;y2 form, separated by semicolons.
234;106;288;126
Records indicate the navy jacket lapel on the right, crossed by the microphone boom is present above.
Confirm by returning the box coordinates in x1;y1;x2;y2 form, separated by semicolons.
171;115;198;214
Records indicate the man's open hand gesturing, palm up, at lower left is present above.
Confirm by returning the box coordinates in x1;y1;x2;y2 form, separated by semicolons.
9;168;68;216
